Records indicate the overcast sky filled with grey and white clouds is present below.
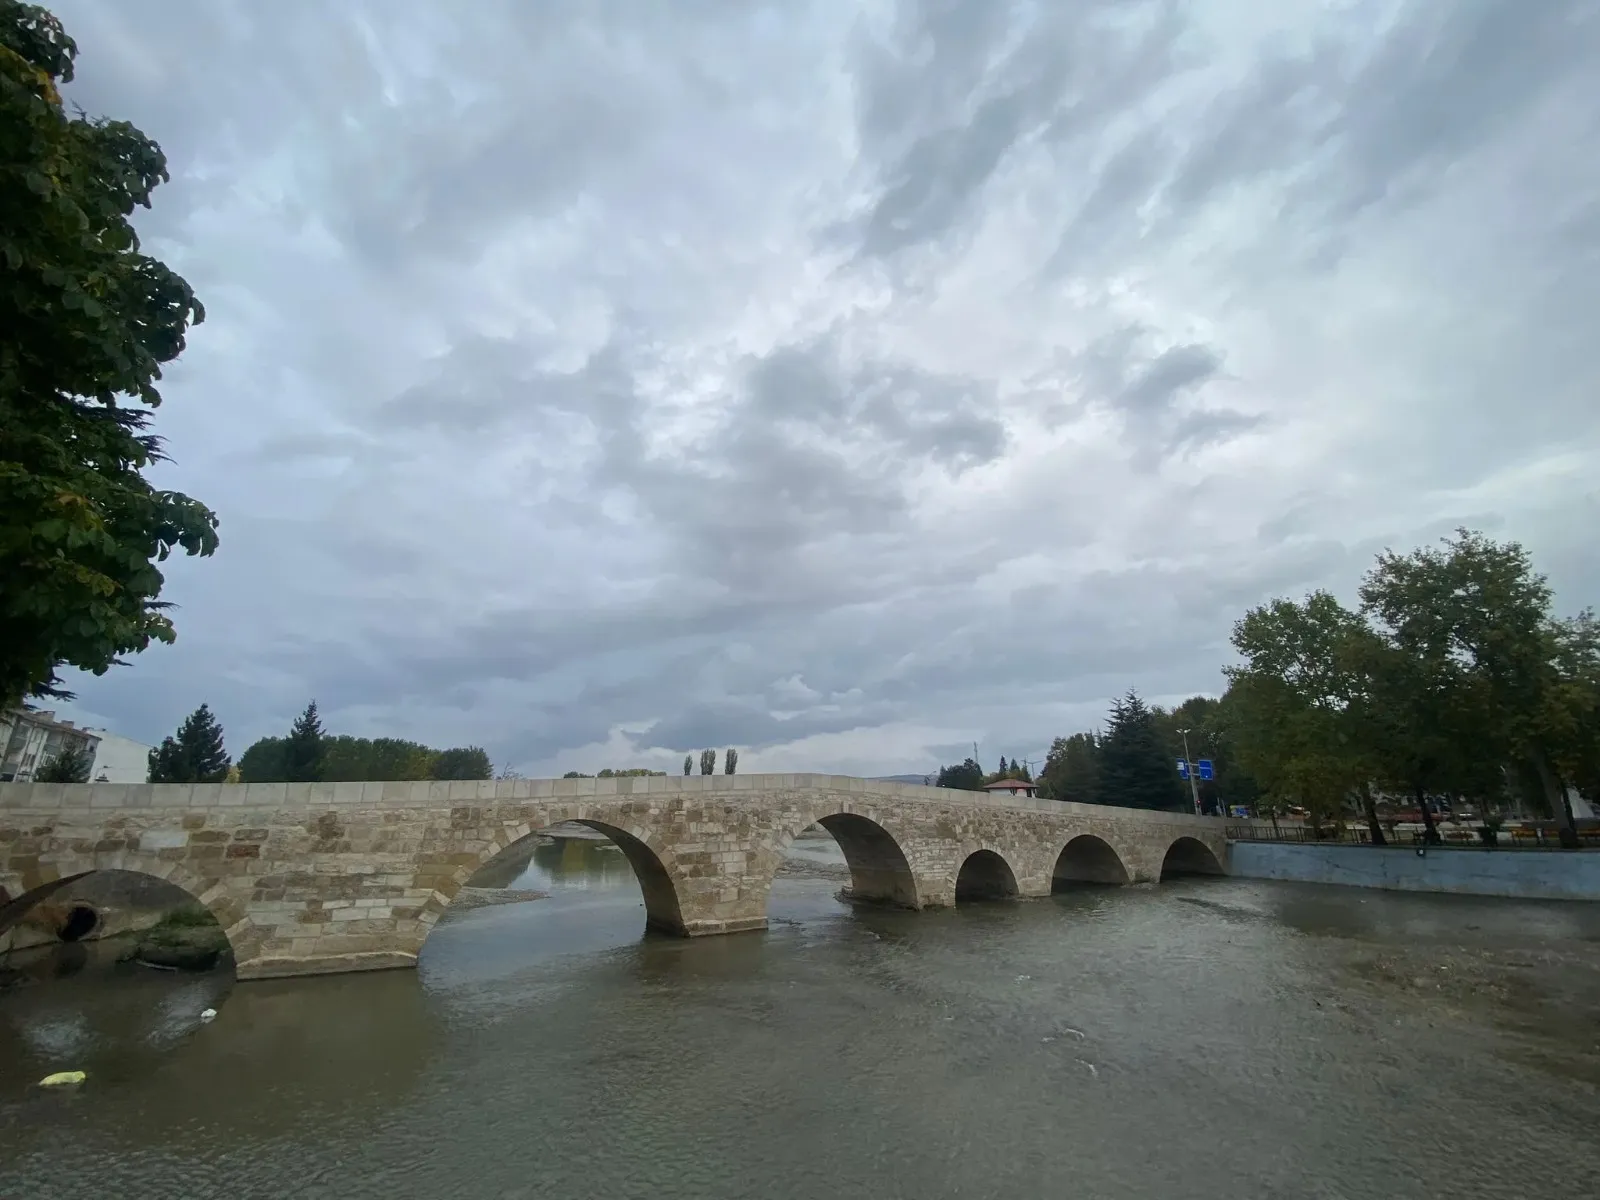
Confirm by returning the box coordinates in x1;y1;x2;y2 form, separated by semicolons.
54;0;1600;774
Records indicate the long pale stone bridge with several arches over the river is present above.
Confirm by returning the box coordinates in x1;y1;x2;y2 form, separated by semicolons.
0;774;1227;979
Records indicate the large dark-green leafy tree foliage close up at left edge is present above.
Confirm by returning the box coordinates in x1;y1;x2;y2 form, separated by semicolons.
0;0;218;706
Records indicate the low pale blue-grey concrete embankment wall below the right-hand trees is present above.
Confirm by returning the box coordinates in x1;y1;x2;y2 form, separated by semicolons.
1229;842;1600;901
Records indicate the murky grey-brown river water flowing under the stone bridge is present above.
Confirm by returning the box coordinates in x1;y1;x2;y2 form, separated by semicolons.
0;842;1600;1200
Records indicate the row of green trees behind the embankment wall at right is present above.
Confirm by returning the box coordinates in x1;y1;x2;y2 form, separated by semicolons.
939;530;1600;845
